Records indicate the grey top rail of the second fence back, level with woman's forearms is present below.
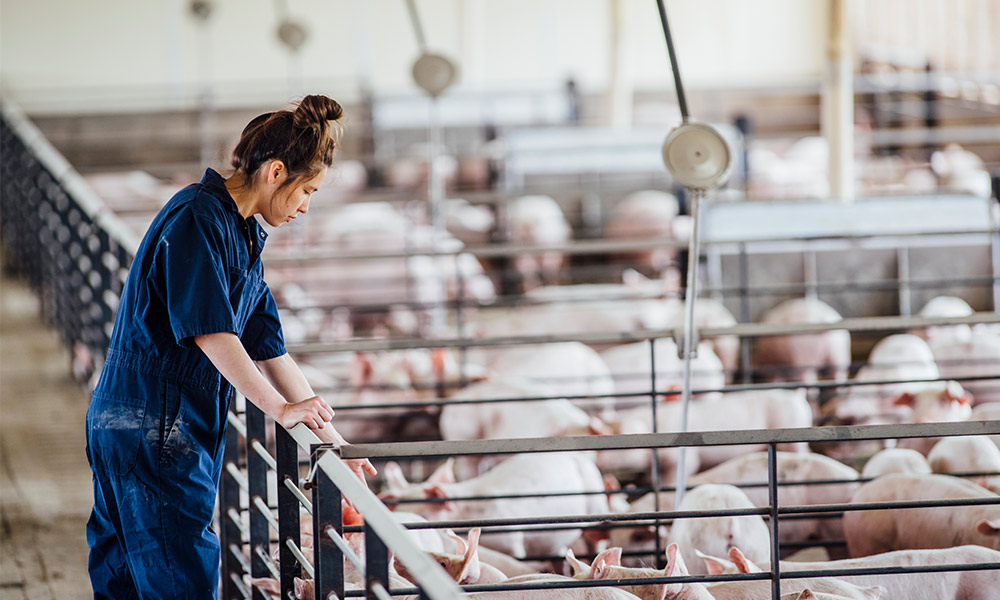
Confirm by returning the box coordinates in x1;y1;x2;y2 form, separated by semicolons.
288;311;1000;354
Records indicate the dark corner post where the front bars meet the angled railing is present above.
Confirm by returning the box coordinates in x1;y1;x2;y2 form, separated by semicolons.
309;447;344;598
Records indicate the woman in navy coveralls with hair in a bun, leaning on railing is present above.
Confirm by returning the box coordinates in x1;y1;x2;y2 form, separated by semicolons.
87;96;374;598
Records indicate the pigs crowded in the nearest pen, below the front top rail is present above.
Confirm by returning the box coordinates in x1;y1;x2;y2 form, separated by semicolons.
251;446;1000;600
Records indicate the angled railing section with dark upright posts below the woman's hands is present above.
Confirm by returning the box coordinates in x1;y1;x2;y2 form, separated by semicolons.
219;404;460;600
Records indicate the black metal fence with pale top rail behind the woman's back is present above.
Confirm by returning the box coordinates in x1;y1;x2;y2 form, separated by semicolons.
0;102;138;379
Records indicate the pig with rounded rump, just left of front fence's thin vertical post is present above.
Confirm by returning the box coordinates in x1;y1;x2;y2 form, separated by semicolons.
670;483;770;575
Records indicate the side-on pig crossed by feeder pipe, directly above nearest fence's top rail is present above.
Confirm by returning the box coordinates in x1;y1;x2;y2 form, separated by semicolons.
597;388;812;478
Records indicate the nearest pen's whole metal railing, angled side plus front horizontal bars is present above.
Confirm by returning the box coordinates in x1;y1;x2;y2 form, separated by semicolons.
222;418;1000;599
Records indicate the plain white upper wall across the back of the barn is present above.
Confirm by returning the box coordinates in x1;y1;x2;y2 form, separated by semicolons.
0;0;828;112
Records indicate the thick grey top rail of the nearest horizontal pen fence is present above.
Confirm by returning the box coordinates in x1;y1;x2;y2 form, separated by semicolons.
340;421;1000;459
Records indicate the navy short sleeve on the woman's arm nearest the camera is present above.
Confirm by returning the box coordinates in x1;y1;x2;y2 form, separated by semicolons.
149;208;237;347
